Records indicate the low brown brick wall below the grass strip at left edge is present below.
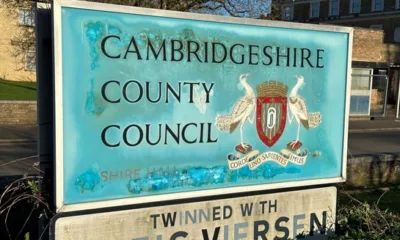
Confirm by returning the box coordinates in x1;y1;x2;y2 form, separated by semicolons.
0;101;37;124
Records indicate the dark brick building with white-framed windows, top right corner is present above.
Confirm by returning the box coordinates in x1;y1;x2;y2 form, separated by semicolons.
282;0;400;43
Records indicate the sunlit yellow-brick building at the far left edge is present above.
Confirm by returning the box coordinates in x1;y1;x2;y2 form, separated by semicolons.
0;1;36;81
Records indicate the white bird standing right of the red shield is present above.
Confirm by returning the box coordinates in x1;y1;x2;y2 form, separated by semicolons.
288;76;322;146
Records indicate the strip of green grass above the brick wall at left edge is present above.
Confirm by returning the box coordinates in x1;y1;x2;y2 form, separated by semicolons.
0;79;36;101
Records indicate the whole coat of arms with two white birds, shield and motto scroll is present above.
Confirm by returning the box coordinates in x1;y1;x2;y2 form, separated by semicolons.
215;74;322;170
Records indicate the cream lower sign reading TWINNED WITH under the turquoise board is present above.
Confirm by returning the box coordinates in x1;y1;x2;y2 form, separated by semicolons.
52;187;337;240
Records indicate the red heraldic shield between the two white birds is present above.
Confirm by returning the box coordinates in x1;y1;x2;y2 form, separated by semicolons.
256;97;287;147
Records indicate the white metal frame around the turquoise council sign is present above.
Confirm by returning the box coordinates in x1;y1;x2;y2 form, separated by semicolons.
53;0;353;212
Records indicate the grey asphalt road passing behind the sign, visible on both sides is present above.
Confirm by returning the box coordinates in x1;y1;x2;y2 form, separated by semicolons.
0;131;400;177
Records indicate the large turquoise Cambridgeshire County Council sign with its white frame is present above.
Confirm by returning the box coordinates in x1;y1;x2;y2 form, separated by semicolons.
54;0;352;212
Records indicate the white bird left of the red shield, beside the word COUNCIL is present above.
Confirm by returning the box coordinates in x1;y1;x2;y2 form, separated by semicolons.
215;74;256;149
